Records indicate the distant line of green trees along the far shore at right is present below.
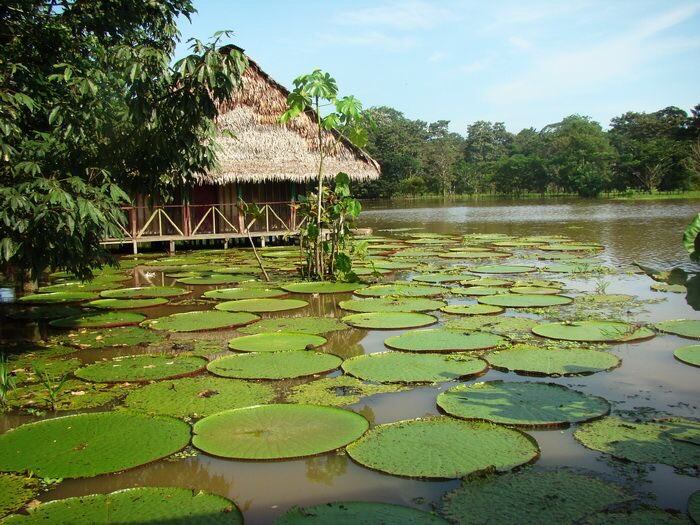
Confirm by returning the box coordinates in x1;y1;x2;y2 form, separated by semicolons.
355;104;700;198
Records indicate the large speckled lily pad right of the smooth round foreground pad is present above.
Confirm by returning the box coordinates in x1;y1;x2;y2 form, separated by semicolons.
347;416;539;479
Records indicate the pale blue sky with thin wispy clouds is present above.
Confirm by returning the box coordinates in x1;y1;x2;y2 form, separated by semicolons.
178;0;700;134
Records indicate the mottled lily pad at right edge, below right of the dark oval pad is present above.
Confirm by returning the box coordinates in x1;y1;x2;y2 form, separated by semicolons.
574;417;700;468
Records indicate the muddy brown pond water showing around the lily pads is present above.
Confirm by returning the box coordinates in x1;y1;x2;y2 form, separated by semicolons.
0;200;700;524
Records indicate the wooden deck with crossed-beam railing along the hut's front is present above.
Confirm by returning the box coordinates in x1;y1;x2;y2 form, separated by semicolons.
103;202;303;253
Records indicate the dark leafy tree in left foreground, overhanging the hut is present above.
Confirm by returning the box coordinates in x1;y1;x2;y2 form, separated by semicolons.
0;0;246;284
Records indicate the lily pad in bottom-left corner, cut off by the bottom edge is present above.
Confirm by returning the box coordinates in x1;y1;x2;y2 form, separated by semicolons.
0;487;243;525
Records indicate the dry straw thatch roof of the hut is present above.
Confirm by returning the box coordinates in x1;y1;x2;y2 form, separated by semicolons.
200;48;380;184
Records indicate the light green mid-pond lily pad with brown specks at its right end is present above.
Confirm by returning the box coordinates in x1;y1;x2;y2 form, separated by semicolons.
343;352;488;383
